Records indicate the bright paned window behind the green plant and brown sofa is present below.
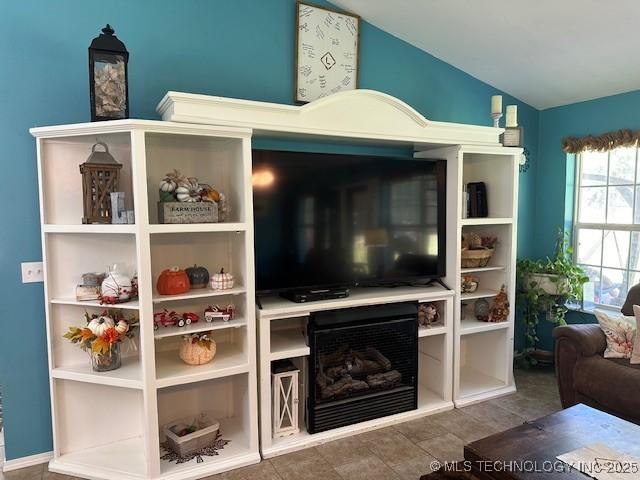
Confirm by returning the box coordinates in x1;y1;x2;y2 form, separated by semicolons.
574;147;640;307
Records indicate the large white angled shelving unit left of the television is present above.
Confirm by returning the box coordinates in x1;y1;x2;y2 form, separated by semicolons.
31;120;260;480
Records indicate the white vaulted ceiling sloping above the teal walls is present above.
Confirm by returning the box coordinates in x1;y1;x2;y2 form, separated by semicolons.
331;0;640;109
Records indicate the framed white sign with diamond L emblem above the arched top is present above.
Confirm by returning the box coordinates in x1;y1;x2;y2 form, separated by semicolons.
295;2;360;102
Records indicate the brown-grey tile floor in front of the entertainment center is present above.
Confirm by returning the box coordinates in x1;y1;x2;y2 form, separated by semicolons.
0;370;560;480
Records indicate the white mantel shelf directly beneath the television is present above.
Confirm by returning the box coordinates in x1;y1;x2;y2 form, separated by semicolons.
258;285;455;320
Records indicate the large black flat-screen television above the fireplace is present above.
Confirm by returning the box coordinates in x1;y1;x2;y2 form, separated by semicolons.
253;150;446;292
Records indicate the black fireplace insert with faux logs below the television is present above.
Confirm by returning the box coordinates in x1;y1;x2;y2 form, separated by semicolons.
307;302;418;433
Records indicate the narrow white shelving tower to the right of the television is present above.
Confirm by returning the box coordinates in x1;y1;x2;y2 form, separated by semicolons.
416;145;522;407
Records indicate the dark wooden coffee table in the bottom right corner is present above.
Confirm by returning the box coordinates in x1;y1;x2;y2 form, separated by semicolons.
464;405;640;480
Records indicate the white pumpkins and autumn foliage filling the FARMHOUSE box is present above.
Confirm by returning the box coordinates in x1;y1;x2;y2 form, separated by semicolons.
159;169;229;221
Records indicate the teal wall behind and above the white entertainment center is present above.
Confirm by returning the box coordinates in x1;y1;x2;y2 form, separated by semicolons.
0;0;538;459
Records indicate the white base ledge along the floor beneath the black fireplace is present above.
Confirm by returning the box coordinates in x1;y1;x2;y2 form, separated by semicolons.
262;386;453;458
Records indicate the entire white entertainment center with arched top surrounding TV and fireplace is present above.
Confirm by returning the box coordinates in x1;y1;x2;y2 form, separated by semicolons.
31;90;522;480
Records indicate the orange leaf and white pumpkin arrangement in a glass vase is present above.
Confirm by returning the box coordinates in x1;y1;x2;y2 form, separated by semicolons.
64;310;138;372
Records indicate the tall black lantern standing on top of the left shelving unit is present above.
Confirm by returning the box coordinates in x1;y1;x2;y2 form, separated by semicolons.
89;24;129;122
